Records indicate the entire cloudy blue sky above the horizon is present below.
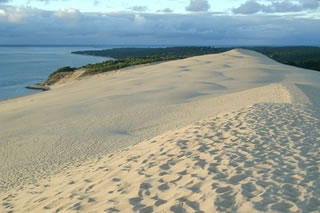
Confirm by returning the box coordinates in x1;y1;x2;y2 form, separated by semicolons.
0;0;320;46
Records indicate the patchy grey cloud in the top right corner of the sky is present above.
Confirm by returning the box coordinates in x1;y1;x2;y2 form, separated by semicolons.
232;0;320;14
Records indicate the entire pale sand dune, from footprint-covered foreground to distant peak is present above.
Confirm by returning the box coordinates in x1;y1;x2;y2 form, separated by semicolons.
0;50;320;212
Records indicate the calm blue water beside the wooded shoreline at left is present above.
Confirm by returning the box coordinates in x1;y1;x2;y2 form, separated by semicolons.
0;46;107;100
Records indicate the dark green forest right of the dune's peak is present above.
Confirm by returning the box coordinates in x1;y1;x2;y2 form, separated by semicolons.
247;46;320;71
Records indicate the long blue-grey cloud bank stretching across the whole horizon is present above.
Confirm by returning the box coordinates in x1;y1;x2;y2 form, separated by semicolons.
0;7;320;45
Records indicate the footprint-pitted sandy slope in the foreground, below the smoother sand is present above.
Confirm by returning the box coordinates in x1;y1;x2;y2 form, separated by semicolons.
0;84;320;213
